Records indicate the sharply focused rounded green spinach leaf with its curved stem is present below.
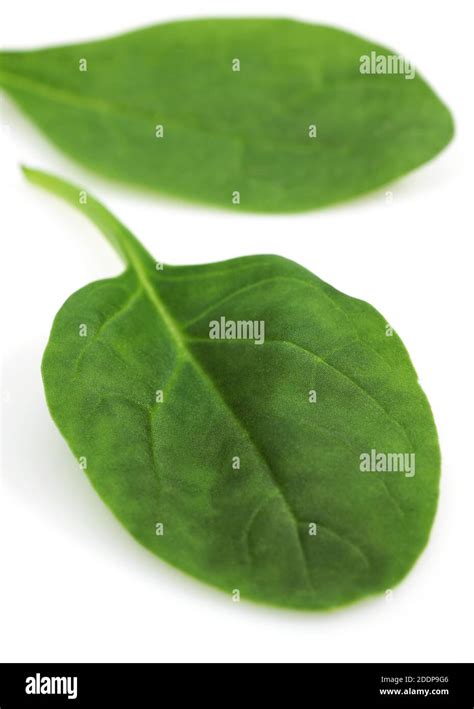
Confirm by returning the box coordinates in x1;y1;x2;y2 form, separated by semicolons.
25;170;440;609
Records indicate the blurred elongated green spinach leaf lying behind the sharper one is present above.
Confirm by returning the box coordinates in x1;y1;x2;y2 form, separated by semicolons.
4;19;453;212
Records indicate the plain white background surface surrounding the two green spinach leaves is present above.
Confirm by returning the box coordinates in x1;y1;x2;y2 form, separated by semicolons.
0;0;474;662
